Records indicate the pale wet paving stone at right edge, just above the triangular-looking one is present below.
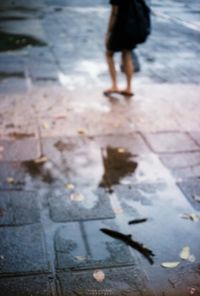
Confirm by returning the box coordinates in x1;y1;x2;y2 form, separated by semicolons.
160;152;200;178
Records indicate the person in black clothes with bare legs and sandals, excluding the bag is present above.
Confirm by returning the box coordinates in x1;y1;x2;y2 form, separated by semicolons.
104;0;135;96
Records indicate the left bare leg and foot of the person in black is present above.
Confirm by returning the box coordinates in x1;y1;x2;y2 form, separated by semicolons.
104;51;119;93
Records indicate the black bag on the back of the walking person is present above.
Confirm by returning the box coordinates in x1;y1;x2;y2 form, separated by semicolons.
125;0;151;44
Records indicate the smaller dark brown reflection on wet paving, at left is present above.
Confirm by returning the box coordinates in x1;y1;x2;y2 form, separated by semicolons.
23;160;54;184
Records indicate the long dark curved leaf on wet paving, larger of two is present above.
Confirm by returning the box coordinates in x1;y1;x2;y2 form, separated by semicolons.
100;228;155;264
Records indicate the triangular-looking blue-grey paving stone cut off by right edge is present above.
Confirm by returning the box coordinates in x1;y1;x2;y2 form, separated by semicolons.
178;178;200;211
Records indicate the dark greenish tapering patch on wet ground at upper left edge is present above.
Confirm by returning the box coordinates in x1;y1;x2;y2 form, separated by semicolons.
0;31;47;52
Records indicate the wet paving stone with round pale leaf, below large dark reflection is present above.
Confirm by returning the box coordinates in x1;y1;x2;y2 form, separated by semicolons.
49;188;115;222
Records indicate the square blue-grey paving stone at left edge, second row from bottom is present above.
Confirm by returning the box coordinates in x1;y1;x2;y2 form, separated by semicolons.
0;224;49;274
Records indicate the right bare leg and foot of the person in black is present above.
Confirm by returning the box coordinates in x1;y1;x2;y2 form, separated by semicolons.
122;50;134;95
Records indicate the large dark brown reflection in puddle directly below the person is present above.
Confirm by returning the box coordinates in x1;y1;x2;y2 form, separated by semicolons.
99;146;138;191
